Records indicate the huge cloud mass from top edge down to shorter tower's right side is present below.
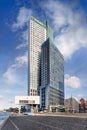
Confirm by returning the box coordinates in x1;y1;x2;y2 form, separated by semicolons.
43;0;87;59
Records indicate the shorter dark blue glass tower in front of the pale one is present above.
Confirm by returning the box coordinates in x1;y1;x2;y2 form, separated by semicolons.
40;38;64;109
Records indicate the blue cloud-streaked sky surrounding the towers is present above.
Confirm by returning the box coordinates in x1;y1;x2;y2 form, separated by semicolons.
0;0;87;109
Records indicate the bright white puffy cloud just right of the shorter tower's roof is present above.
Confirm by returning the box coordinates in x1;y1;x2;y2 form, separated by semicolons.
54;27;87;59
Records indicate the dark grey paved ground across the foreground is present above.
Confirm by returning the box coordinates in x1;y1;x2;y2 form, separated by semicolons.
1;116;87;130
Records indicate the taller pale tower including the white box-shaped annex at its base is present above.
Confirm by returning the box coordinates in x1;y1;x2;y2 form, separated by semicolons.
15;16;53;111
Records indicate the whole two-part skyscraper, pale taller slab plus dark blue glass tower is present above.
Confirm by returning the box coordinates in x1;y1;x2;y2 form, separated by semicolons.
28;17;64;109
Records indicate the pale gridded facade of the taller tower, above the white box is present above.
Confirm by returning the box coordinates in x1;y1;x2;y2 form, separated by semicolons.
28;17;46;96
